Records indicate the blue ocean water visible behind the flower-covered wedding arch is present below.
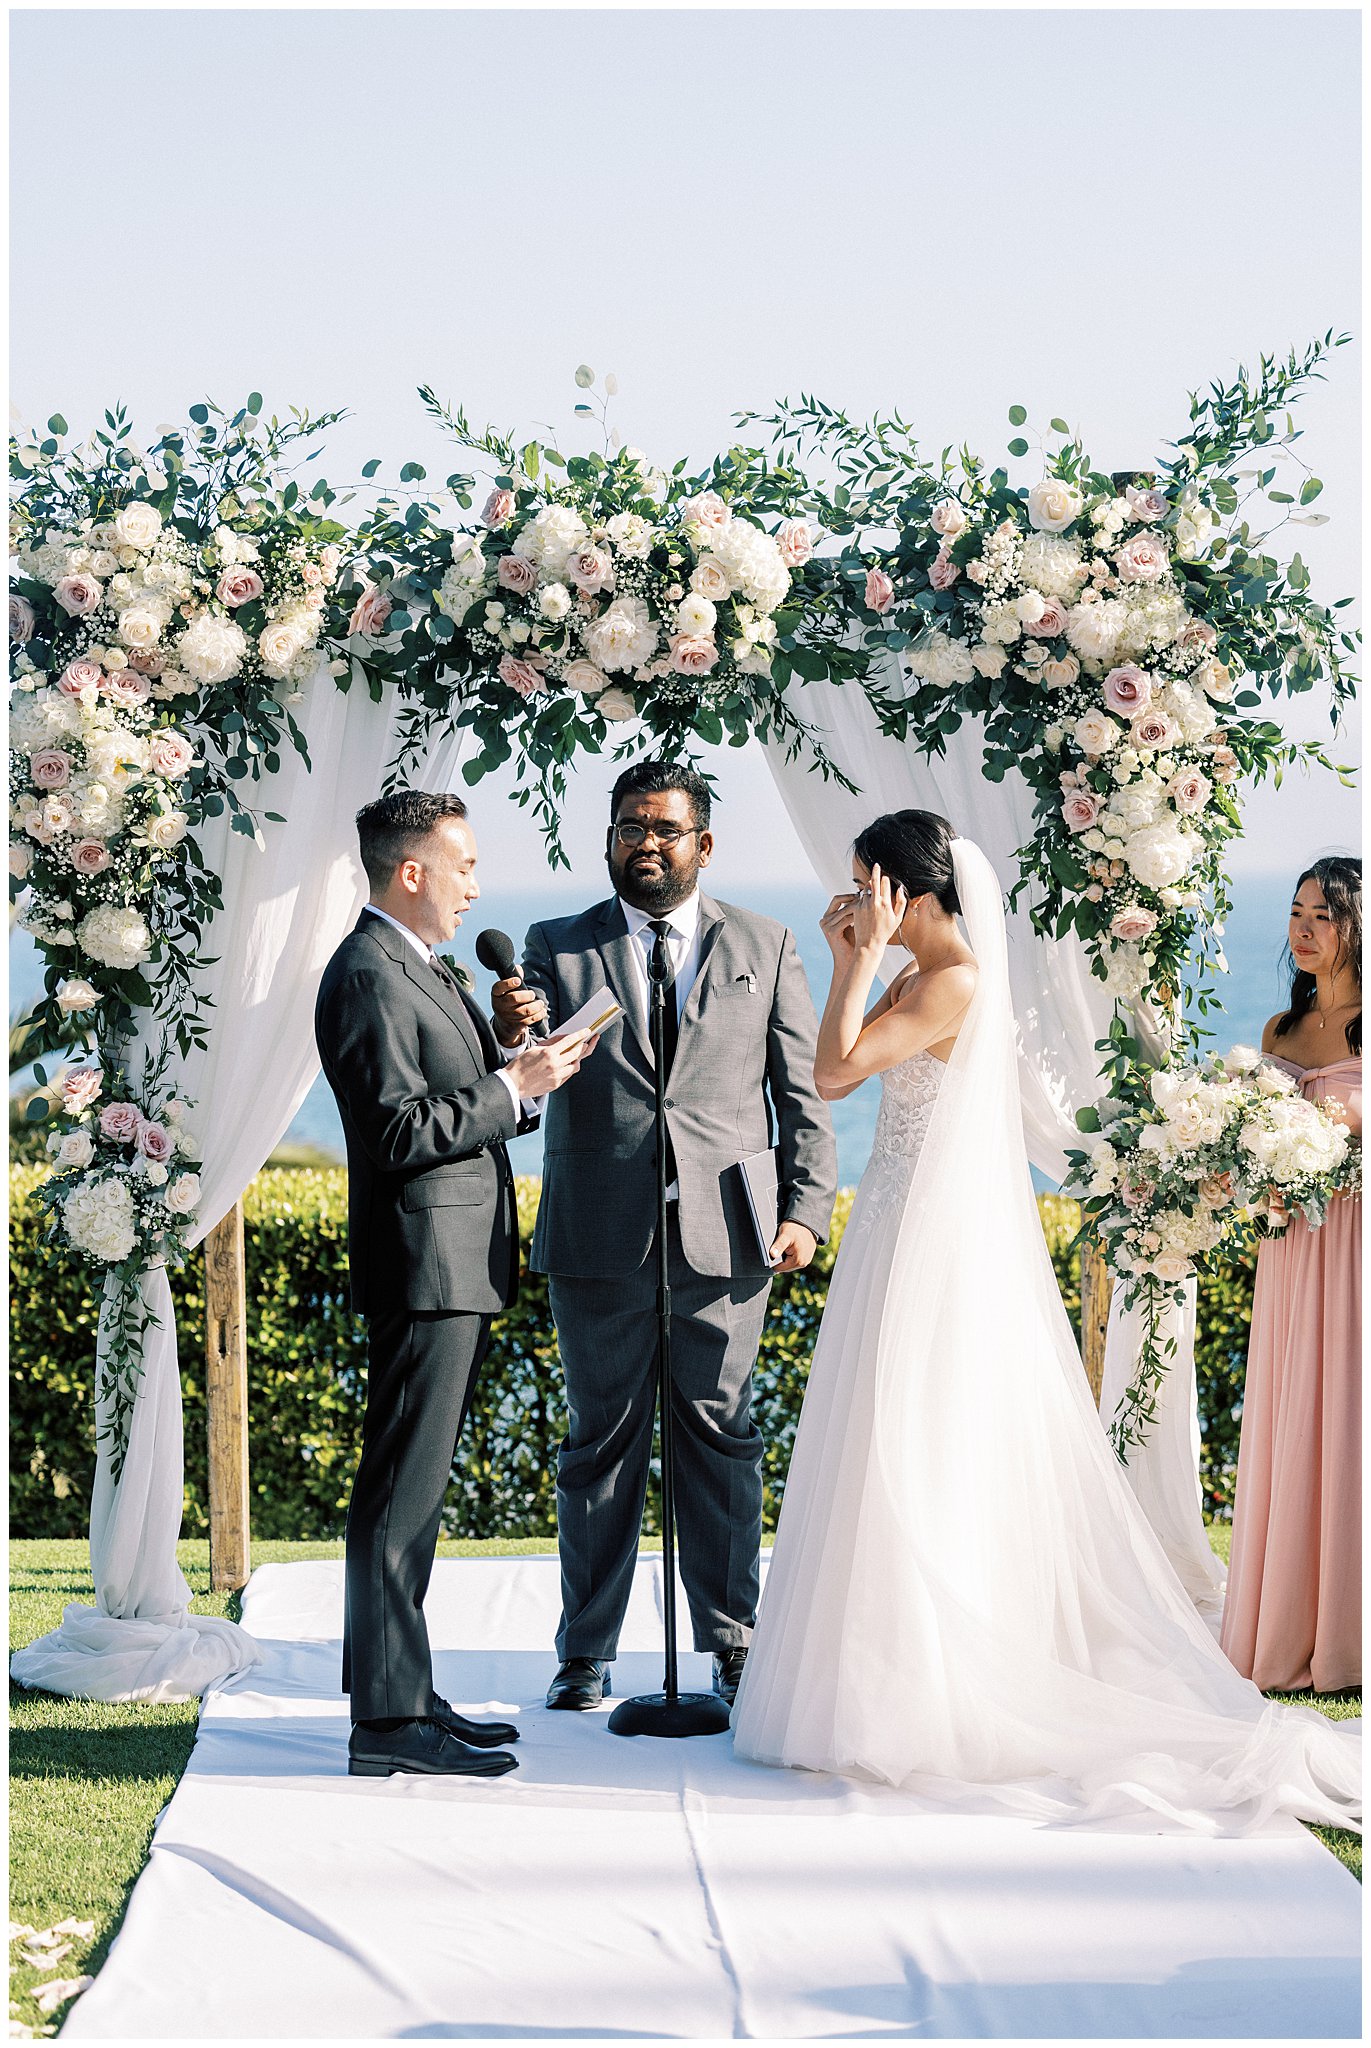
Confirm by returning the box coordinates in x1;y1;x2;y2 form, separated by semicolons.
10;872;1293;1188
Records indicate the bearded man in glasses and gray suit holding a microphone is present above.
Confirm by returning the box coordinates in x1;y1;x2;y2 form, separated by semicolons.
494;762;836;1708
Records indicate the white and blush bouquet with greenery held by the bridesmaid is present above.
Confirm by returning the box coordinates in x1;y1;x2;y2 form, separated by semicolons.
1068;1047;1361;1456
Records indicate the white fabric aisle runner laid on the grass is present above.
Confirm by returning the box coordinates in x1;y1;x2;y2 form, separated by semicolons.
64;1559;1361;2040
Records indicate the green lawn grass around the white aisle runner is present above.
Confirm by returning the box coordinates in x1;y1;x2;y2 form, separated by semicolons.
10;1528;1361;2034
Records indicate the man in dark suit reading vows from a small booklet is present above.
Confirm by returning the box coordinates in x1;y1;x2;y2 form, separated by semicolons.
314;788;592;1778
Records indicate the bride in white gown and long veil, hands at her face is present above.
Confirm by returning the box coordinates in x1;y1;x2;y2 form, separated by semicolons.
734;811;1361;1833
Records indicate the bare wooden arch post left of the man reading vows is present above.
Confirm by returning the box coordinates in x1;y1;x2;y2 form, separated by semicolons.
205;1202;252;1593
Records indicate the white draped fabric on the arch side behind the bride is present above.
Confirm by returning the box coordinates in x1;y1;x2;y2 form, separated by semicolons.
766;657;1223;1618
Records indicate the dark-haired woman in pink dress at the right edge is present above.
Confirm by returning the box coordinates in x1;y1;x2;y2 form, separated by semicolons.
1221;856;1361;1692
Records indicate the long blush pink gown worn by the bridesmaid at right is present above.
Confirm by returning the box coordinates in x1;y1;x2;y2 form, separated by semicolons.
1221;1059;1361;1692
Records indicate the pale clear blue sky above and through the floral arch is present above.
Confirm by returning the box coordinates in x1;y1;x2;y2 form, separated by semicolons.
10;8;1361;899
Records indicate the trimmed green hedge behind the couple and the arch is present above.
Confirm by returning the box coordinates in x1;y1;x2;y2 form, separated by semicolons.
10;1167;1252;1540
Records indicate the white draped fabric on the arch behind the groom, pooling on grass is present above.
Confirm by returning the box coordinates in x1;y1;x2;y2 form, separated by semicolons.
10;662;471;1700
